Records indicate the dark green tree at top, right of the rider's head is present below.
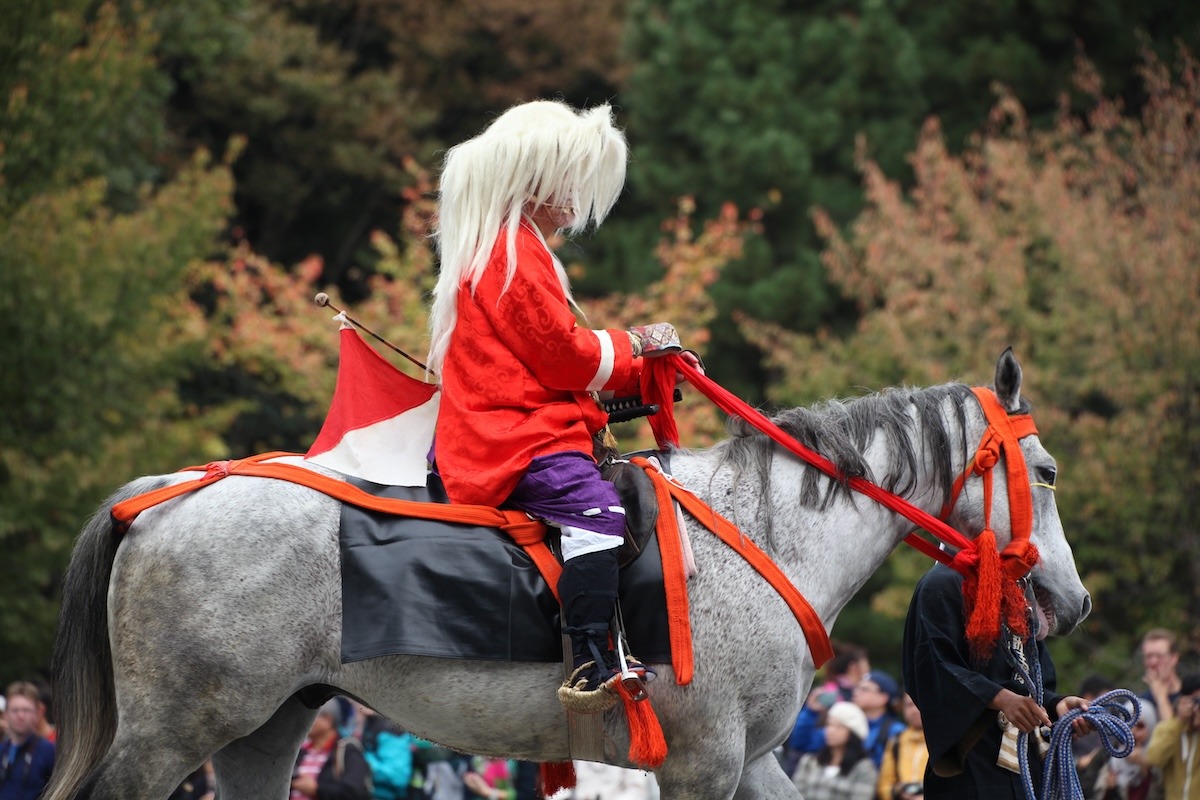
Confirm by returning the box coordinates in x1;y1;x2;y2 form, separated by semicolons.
619;0;1200;397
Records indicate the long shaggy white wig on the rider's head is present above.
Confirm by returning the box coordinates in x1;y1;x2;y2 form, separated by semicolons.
427;101;629;372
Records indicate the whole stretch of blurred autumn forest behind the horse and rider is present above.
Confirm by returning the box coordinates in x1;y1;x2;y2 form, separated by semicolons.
0;0;1200;687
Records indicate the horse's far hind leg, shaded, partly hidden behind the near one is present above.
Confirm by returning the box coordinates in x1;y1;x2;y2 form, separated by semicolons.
212;696;317;800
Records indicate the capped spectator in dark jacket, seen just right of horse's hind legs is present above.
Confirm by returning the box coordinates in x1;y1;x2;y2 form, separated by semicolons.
288;697;371;800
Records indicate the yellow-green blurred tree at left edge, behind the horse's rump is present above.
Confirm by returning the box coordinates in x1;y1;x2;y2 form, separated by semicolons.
0;162;232;678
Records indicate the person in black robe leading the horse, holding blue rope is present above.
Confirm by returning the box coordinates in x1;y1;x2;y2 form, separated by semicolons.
904;564;1090;800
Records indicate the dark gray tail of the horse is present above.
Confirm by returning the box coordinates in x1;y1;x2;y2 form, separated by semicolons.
42;479;166;800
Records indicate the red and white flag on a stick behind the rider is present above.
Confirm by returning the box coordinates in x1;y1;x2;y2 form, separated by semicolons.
305;321;440;486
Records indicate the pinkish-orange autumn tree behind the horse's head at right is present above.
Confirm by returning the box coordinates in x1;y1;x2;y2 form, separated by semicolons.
746;53;1200;686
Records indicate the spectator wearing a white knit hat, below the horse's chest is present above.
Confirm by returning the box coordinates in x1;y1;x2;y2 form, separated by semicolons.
792;700;878;800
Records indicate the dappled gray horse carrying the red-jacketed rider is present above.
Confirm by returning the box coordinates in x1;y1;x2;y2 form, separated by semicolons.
46;353;1091;800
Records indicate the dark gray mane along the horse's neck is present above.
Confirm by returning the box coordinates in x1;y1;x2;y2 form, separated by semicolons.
713;384;971;509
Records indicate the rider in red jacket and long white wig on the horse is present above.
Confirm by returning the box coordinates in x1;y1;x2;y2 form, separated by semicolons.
428;101;696;711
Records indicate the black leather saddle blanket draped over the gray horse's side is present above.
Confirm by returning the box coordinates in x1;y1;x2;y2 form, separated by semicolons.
340;479;671;663
